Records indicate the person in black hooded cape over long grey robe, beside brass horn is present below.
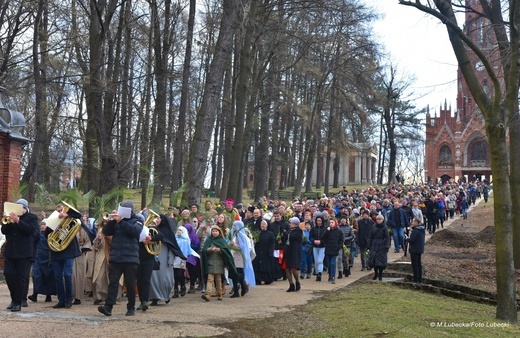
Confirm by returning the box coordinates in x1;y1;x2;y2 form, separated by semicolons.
149;214;186;306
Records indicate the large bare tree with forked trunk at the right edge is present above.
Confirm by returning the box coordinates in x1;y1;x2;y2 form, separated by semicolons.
399;0;520;323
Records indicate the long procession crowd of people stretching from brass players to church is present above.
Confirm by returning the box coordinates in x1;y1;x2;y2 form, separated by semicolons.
2;182;489;316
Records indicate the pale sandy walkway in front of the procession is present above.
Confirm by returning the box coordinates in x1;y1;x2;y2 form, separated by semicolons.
0;202;480;338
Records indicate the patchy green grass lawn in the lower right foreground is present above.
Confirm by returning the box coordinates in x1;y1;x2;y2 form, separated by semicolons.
224;282;520;337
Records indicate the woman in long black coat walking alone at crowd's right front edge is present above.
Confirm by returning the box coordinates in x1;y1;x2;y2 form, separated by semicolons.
368;215;390;280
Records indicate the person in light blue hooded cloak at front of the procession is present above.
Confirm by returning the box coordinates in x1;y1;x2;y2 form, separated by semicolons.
229;221;256;298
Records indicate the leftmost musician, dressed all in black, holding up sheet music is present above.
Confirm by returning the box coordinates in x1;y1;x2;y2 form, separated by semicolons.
1;199;40;312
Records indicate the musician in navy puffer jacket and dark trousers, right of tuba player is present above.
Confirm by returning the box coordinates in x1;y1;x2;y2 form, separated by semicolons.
98;200;142;316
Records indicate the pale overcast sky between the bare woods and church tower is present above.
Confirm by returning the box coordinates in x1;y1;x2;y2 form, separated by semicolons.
365;0;457;114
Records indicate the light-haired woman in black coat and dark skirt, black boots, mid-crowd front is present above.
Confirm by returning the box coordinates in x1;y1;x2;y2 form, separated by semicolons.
282;217;303;292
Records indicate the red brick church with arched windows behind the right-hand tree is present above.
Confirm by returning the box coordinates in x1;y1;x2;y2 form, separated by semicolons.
425;1;495;182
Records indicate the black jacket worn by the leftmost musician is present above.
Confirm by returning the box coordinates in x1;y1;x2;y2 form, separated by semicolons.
1;212;39;258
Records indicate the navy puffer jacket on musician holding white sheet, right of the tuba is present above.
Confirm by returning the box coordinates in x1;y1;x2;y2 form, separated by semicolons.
103;214;142;264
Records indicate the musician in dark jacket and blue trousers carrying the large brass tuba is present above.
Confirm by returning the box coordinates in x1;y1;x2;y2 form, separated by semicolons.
42;204;93;309
